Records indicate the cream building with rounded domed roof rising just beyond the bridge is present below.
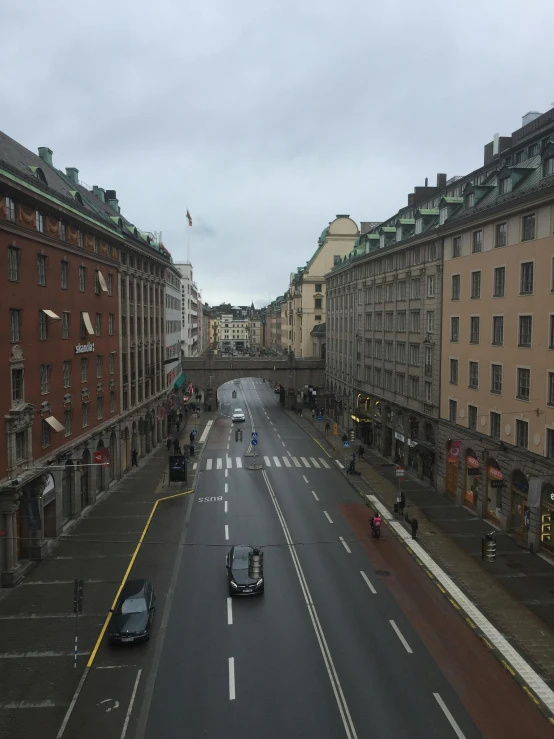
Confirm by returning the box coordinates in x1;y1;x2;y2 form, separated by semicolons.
281;215;360;357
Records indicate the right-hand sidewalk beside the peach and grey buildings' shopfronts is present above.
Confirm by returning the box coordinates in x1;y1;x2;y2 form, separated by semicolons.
287;411;554;688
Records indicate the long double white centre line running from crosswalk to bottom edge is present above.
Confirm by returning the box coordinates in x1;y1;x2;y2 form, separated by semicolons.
262;470;358;739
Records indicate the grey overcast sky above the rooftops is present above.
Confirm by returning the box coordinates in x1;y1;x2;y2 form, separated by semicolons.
0;0;554;306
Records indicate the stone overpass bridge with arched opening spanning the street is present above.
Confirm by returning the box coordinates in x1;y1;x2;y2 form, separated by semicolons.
182;354;325;408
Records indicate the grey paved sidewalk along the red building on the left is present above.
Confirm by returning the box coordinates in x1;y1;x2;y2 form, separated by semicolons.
0;404;217;739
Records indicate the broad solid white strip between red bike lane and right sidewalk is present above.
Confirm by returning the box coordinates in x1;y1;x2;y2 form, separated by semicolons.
367;502;554;713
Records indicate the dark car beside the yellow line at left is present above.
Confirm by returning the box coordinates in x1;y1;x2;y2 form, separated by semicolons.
108;580;156;643
